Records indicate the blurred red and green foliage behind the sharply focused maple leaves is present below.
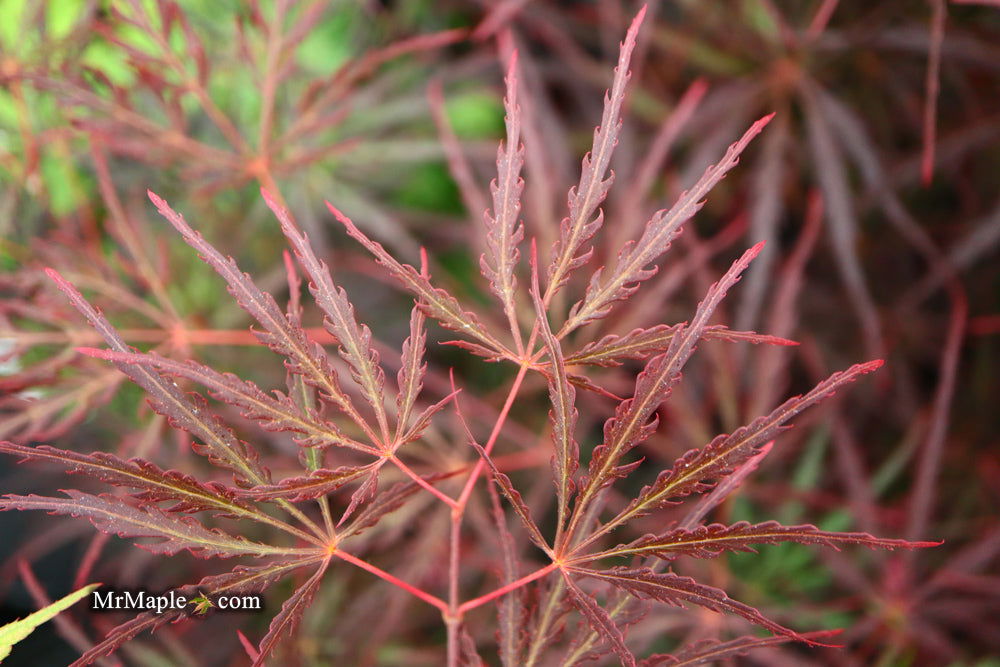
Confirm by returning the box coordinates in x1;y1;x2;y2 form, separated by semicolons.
0;0;1000;667
